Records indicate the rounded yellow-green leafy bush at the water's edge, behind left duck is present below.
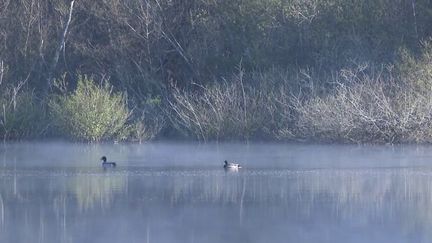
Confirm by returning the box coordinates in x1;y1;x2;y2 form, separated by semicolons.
49;76;130;141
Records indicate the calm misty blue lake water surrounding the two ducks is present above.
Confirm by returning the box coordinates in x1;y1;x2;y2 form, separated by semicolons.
0;142;432;243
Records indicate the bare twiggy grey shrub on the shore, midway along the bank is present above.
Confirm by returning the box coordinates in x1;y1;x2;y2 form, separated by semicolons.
169;76;268;141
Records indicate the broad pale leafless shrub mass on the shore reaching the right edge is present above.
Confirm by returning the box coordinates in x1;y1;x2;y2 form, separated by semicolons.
286;64;432;143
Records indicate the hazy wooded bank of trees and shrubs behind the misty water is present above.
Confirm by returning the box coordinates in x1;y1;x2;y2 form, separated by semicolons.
0;0;432;142
